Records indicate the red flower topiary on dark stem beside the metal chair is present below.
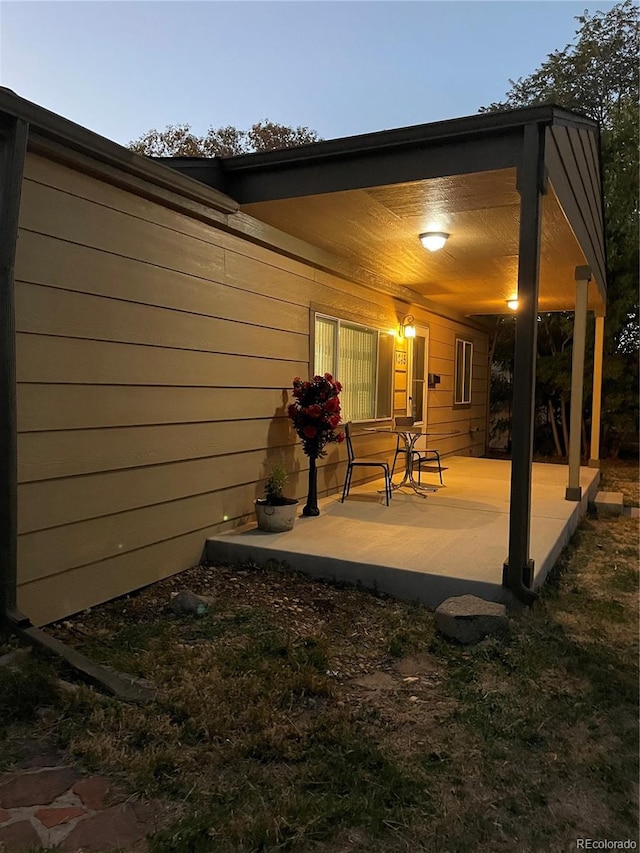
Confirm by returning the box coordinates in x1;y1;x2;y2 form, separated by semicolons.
287;373;344;516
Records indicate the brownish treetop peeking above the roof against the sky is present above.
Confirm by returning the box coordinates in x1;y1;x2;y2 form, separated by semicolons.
129;119;320;157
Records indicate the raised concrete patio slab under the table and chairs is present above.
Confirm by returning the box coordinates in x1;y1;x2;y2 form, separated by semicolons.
206;456;600;607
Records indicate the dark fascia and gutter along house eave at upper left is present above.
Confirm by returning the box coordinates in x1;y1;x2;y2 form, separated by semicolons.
0;86;238;213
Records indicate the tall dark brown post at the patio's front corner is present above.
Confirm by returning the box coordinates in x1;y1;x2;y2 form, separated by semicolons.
502;124;545;604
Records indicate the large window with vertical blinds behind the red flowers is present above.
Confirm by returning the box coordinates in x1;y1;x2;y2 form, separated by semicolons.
314;314;394;421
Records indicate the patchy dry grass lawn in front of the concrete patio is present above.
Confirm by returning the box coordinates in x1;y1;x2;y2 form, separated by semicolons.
0;467;638;853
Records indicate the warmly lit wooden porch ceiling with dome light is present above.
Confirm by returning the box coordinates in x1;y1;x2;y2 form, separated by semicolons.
242;168;601;315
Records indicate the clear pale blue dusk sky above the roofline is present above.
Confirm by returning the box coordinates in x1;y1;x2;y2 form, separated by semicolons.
0;0;613;145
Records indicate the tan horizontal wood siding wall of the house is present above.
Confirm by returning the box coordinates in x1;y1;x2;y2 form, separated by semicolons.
16;154;487;624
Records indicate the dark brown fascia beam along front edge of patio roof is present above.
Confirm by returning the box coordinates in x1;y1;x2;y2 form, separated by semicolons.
175;106;596;204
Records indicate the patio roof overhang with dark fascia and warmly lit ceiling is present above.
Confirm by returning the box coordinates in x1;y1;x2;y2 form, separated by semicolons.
163;106;606;315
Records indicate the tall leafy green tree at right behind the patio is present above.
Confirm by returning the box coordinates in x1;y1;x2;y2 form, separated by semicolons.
481;0;640;455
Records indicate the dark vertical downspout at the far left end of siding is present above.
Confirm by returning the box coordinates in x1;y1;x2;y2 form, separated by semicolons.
0;115;28;634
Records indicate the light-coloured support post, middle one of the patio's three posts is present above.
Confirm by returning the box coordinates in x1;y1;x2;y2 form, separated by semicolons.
565;267;591;501
